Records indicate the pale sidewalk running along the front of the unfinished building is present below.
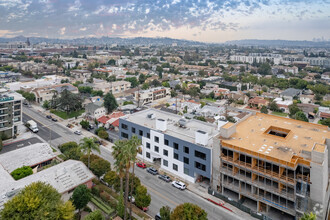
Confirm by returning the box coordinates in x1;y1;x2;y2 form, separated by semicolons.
187;183;255;220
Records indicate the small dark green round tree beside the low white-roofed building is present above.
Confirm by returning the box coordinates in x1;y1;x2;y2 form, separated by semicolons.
72;185;91;219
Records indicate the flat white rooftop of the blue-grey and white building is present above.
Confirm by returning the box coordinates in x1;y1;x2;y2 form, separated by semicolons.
121;108;219;147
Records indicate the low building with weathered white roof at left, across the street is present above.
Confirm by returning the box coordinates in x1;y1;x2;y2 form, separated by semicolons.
0;143;95;210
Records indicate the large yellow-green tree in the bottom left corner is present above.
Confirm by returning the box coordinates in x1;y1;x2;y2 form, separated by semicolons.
0;182;74;220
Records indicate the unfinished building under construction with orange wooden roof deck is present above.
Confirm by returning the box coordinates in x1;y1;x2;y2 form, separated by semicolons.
212;113;330;219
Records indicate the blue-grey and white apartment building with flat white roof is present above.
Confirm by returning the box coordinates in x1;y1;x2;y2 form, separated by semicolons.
119;109;219;182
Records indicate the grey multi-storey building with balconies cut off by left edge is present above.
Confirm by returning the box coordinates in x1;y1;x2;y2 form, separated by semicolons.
0;89;24;139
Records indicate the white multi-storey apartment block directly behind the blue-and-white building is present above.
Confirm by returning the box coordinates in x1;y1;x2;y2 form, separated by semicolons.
134;87;171;105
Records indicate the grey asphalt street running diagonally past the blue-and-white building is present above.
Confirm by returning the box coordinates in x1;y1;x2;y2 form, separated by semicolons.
23;108;241;220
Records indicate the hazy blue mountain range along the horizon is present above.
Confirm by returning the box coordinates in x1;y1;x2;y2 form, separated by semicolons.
0;36;330;48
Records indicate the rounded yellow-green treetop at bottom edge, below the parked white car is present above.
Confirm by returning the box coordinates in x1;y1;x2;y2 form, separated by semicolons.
171;203;207;220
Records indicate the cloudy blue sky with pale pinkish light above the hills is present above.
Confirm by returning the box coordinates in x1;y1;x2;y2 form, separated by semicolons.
0;0;330;42
